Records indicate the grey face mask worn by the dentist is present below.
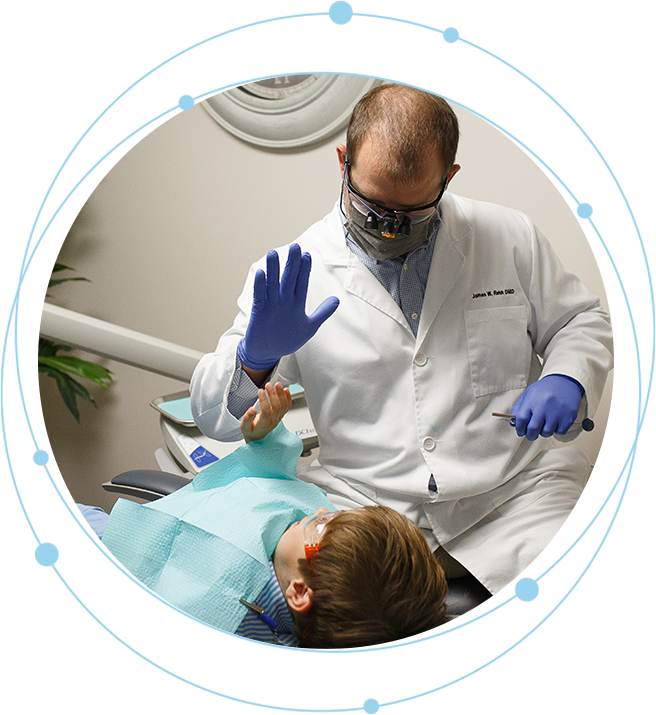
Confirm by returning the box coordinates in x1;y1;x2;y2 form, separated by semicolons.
340;164;446;261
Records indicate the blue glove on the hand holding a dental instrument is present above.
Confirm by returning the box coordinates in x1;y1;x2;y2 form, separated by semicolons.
512;375;585;441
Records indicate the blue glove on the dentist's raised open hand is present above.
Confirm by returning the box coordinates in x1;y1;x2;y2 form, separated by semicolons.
237;243;339;370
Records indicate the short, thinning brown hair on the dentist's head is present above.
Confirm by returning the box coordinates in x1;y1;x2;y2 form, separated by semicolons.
346;84;459;184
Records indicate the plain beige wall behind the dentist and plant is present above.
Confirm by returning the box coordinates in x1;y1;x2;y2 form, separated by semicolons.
39;85;611;510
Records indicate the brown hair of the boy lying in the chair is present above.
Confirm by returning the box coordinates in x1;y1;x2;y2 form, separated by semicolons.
296;506;448;648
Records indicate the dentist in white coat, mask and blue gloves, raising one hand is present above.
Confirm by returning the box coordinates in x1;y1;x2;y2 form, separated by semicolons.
191;84;612;602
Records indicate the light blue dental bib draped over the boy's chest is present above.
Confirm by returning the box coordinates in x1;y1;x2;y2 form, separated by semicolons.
102;423;335;633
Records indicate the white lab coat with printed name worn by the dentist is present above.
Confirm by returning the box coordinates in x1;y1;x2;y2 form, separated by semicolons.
191;193;612;593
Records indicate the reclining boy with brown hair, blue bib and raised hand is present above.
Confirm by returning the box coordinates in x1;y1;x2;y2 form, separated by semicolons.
78;383;448;648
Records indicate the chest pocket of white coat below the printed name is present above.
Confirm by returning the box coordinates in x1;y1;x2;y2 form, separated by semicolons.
465;305;531;397
